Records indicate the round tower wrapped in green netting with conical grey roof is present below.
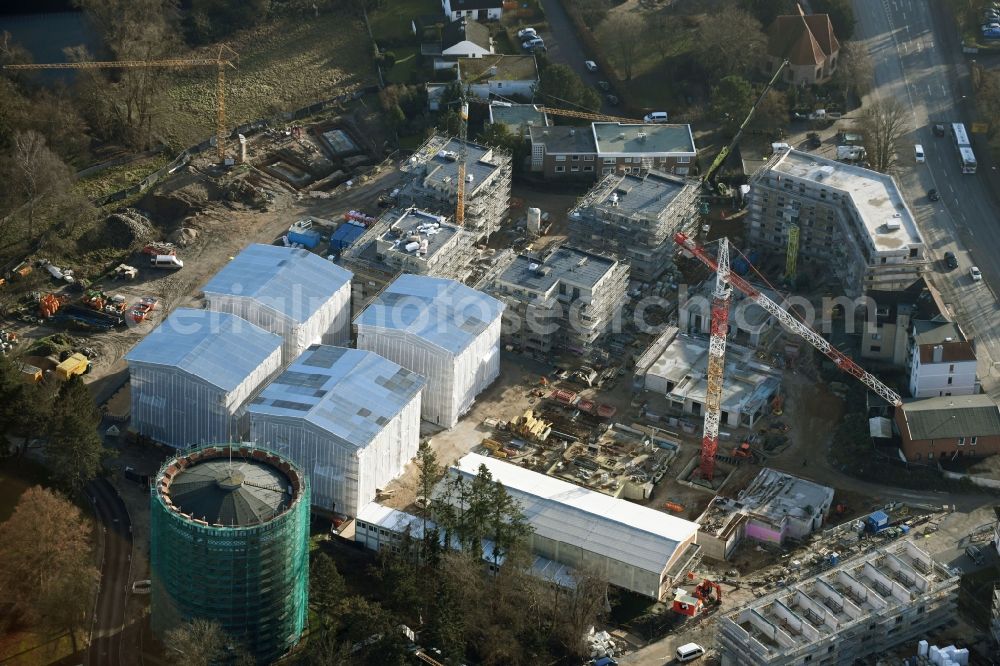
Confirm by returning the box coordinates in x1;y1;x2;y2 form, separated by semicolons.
150;444;310;664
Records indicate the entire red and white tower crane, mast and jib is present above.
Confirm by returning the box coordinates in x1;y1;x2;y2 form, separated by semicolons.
674;233;903;479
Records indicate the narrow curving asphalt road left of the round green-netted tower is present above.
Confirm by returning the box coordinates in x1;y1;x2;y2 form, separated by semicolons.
87;479;137;666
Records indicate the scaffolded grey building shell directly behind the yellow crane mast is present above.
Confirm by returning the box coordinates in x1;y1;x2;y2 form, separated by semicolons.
398;134;511;238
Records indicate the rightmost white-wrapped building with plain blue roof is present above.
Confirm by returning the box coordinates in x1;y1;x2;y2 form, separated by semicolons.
354;275;504;428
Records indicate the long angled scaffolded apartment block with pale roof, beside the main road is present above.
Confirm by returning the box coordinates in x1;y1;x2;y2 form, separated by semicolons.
747;150;927;298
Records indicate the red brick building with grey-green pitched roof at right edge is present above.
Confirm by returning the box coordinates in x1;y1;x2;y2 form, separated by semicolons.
896;394;1000;462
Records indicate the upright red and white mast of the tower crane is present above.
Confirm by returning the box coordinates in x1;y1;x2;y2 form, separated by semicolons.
701;238;732;481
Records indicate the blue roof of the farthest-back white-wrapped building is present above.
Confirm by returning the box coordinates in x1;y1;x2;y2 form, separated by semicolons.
202;243;353;323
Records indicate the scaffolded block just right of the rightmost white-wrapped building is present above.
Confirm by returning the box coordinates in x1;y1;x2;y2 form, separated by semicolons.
492;246;629;353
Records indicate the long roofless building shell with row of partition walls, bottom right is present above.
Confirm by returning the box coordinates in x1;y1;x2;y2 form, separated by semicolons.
718;540;959;666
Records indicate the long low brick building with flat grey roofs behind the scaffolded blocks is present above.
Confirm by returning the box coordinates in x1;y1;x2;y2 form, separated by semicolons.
531;122;698;180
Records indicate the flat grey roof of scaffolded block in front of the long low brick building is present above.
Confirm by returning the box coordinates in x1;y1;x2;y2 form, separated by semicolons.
571;171;689;218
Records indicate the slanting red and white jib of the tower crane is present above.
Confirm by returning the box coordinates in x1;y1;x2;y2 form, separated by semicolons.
674;233;903;407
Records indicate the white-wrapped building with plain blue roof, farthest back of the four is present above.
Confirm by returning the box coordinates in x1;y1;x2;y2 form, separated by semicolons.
203;244;353;365
